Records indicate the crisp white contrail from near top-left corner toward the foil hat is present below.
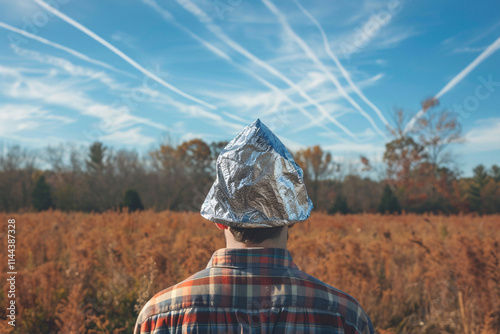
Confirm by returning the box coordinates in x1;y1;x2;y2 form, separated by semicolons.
33;0;217;109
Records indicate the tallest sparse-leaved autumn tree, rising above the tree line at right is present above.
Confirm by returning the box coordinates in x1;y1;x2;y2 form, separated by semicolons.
384;98;463;212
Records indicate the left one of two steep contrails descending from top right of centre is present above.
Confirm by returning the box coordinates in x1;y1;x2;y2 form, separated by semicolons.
262;0;385;137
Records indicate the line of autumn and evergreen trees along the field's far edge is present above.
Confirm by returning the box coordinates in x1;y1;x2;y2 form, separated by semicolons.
0;99;500;214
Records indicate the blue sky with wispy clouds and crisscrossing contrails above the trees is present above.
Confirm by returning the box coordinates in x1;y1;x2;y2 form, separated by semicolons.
0;0;500;174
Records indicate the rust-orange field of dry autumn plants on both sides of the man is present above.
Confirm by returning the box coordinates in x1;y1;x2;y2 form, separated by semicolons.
0;211;500;333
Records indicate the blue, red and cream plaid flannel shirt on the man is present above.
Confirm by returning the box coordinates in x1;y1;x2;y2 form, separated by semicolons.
134;248;374;334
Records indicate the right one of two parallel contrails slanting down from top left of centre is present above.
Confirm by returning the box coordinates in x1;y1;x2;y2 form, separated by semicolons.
174;0;357;140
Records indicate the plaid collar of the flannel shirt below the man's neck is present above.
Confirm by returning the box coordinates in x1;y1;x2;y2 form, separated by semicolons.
207;248;297;268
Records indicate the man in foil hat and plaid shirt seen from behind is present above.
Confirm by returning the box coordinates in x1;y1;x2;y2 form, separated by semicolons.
134;120;374;334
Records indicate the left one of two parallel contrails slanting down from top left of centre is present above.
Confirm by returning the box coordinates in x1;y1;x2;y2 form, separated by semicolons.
143;0;337;134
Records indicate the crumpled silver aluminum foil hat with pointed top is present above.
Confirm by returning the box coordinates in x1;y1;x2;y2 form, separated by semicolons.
200;119;313;228
